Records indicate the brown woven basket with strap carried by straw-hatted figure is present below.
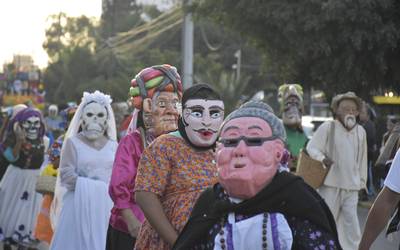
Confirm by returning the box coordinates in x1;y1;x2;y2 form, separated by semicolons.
296;122;335;189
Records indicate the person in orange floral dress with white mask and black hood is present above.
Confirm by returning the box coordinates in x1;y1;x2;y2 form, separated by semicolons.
135;84;224;250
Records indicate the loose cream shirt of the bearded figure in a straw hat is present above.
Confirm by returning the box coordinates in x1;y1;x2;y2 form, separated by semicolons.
307;120;367;190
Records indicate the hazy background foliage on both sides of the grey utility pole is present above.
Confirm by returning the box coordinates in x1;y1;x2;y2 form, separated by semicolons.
44;1;277;108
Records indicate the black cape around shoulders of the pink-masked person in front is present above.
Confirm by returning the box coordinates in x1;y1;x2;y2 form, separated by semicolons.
173;172;341;249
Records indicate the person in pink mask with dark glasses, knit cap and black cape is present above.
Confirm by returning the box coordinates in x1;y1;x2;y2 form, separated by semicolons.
173;101;341;250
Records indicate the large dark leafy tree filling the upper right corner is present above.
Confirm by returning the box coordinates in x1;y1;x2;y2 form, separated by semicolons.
193;0;400;97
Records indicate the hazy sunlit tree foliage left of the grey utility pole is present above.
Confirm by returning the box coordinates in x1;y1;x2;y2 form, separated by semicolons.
43;5;181;103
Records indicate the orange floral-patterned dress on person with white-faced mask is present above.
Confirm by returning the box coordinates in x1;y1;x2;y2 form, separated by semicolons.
135;134;217;250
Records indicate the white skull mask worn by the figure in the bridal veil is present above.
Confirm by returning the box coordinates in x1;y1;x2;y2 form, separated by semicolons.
81;102;108;140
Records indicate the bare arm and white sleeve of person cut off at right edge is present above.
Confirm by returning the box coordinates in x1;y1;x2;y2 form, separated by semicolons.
359;150;400;250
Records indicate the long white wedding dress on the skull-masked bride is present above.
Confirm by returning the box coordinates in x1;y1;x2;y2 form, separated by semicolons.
50;136;117;250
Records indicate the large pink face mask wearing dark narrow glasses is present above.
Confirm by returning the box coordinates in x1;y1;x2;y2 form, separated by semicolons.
217;117;284;199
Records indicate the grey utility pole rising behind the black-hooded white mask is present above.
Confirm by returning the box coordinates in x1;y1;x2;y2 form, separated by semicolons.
182;0;193;89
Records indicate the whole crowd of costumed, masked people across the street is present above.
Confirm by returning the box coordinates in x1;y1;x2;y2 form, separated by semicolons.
0;64;400;250
